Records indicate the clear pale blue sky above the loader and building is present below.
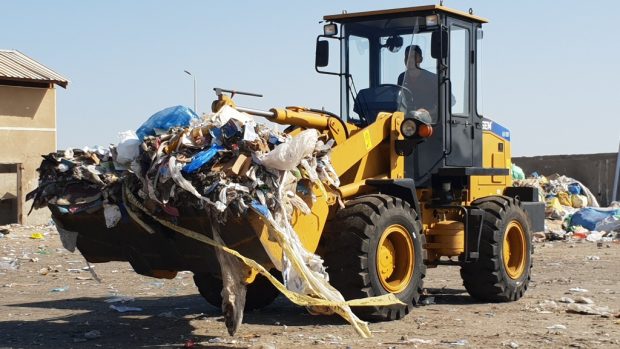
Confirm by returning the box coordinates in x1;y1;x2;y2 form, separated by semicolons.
0;0;620;156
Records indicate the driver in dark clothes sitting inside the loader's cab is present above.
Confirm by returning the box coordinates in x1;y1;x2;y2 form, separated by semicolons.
398;45;439;120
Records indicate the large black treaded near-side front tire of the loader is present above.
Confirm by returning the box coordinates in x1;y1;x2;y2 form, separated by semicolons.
320;194;426;321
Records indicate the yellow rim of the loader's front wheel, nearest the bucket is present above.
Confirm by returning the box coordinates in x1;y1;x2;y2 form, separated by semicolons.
377;224;415;293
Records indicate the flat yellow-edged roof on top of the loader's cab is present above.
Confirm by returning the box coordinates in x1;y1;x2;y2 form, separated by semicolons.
323;5;488;23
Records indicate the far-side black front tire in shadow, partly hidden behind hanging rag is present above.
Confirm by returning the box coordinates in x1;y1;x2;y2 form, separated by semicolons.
194;273;280;311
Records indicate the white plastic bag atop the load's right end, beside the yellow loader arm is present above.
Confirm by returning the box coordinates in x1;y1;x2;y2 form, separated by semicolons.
258;129;319;171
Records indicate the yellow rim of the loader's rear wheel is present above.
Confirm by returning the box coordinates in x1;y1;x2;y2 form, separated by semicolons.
502;221;527;280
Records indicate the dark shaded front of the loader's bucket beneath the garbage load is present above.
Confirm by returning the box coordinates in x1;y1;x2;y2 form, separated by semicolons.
49;204;272;276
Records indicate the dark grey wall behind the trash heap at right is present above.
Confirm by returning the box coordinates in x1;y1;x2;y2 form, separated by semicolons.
512;153;618;206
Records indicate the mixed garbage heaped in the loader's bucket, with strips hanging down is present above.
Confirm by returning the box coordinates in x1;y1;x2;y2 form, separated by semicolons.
28;106;398;337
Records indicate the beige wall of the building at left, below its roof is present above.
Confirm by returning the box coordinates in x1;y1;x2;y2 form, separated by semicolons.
0;85;56;225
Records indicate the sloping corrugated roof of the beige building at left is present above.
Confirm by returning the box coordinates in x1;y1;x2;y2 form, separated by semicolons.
0;50;69;88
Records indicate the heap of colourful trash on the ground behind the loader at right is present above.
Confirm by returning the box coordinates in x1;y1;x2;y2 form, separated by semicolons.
512;164;620;242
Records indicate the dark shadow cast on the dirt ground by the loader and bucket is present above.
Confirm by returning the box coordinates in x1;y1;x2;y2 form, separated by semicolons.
0;288;475;348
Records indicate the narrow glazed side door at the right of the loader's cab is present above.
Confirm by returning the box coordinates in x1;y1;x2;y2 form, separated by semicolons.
445;18;482;167
